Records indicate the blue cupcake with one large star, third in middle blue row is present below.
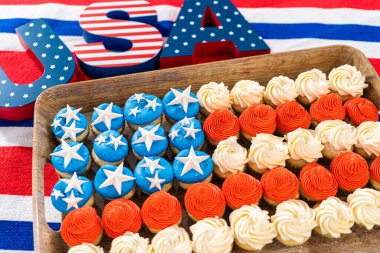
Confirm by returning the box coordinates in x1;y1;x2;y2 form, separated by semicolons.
131;125;168;160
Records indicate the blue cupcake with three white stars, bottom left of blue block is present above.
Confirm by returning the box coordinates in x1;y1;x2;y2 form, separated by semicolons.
51;172;94;213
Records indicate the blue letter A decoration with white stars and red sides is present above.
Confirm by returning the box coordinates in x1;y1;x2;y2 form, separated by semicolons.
160;0;270;68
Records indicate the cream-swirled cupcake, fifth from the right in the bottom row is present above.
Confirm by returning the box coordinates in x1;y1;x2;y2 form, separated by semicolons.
190;217;234;253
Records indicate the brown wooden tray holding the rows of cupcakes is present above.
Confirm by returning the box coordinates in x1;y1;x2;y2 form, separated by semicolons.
33;46;380;253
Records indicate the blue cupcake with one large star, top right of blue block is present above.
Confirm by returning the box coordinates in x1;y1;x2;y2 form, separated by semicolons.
162;86;199;124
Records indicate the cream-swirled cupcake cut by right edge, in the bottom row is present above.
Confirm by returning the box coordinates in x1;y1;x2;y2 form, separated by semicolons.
347;188;380;230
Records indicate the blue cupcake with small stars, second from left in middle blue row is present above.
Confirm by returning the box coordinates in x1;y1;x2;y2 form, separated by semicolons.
92;130;128;166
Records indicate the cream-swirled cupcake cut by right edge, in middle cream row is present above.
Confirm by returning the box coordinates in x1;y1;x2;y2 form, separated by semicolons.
355;121;380;159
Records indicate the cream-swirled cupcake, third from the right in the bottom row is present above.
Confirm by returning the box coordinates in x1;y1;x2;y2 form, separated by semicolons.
271;199;317;246
